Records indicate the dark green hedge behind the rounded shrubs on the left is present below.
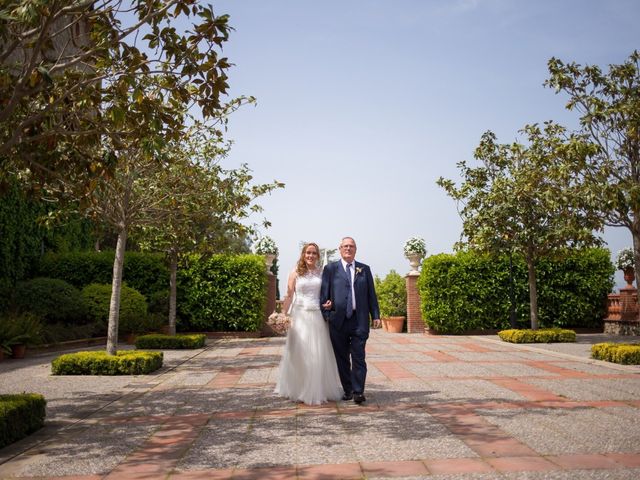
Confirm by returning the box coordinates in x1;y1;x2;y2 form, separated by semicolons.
38;251;169;298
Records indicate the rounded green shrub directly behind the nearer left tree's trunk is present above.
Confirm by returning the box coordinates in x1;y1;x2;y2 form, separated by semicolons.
82;283;147;333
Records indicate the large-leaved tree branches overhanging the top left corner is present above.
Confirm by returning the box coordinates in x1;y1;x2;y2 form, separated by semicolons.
0;0;230;194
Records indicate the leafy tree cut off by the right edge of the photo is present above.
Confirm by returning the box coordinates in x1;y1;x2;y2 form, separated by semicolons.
546;50;640;284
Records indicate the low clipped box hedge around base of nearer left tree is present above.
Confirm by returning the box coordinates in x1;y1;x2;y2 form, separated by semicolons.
51;350;163;375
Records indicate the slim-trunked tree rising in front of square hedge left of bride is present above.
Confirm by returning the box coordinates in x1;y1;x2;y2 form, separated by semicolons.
141;124;284;335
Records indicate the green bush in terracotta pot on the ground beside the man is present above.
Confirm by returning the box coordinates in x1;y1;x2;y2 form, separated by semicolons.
375;270;407;333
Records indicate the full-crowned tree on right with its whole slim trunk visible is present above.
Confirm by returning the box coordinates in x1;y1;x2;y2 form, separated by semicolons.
437;122;602;329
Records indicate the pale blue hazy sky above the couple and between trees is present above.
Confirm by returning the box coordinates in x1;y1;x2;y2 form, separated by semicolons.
213;0;640;294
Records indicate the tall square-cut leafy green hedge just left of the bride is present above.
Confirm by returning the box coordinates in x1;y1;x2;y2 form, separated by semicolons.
178;255;267;332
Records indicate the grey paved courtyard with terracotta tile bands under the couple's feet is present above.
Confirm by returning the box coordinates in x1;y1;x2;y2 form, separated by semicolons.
0;331;640;480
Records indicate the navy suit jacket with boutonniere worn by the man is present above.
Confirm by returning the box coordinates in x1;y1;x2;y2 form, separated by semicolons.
320;260;380;333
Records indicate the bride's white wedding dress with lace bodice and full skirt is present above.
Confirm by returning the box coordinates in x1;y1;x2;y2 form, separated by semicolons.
274;273;342;405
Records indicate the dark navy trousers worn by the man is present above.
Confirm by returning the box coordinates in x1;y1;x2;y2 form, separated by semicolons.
329;312;368;393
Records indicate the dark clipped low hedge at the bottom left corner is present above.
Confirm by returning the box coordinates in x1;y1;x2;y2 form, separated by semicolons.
0;393;47;448
